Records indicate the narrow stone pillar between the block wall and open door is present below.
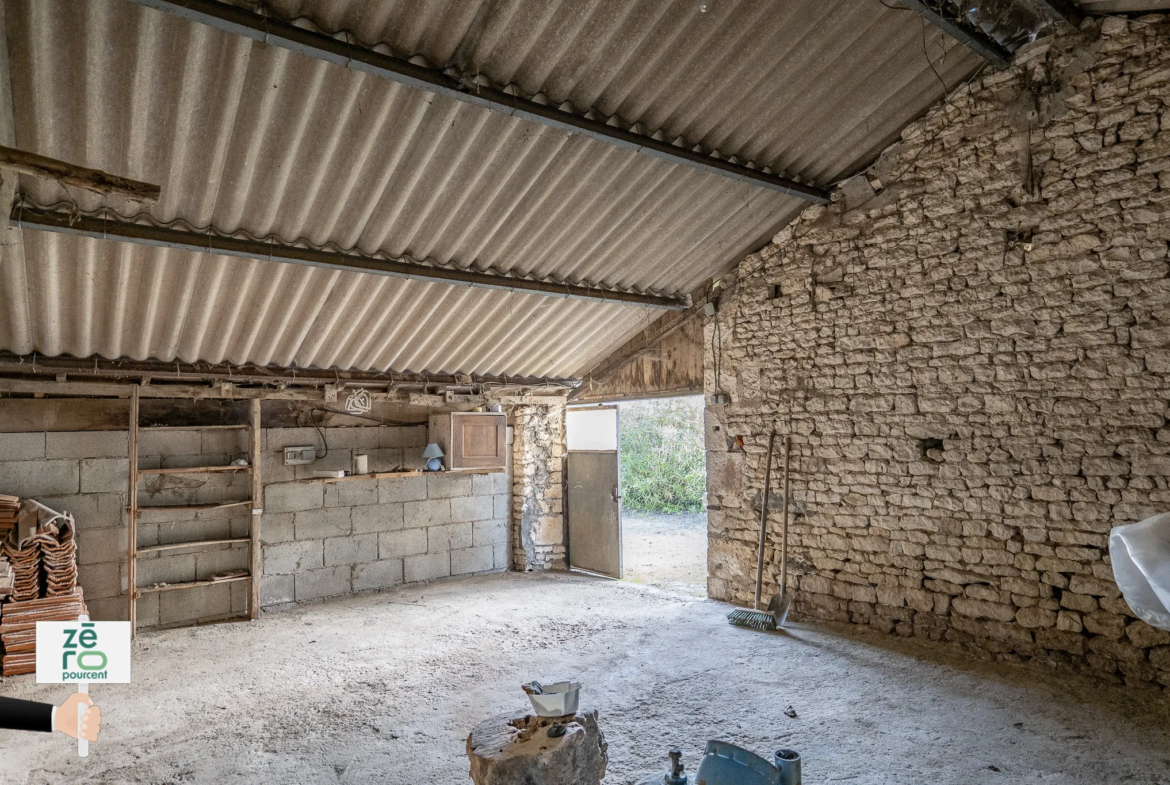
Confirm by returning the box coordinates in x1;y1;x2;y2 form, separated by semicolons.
511;405;565;571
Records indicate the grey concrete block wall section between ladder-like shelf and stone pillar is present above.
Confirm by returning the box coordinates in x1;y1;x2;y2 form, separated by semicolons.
261;427;510;606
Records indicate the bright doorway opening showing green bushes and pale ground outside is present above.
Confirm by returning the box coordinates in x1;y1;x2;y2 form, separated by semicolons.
618;395;707;597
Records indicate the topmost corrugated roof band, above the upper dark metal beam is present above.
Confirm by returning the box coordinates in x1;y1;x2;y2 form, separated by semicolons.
258;0;983;184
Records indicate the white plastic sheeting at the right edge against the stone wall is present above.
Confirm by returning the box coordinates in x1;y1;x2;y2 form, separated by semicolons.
1109;512;1170;629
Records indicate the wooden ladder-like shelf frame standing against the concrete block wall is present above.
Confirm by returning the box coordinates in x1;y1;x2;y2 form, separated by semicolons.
126;387;263;635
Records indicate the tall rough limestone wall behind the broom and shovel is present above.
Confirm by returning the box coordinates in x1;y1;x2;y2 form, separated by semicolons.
706;16;1170;686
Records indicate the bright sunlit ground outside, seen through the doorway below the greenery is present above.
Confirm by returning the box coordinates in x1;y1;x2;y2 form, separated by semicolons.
621;510;707;597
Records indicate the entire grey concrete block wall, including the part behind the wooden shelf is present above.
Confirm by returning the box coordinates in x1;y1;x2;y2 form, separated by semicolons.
0;424;511;626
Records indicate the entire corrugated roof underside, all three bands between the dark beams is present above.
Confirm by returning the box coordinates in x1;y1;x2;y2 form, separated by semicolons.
0;0;982;377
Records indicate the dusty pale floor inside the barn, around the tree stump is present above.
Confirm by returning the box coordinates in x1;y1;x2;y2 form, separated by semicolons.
0;574;1170;785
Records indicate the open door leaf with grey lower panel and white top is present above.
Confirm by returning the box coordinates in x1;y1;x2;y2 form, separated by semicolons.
565;406;621;578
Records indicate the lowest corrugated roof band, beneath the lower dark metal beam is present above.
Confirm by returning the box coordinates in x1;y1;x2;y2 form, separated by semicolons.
0;230;659;377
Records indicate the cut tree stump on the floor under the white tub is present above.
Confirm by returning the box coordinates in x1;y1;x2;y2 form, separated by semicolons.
467;710;610;785
